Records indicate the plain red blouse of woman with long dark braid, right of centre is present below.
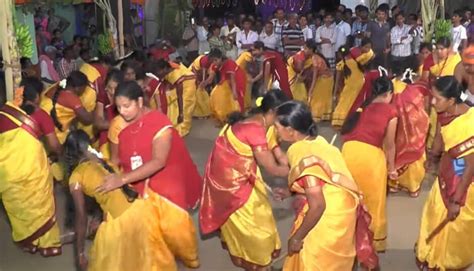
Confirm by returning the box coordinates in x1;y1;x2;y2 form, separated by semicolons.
343;103;398;148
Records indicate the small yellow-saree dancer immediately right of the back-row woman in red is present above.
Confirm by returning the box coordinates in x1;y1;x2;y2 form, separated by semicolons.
288;51;312;103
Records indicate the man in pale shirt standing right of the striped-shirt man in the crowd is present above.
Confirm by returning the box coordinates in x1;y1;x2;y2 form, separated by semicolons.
315;13;337;69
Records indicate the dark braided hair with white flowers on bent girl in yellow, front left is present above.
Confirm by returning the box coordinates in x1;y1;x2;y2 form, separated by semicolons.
64;130;138;202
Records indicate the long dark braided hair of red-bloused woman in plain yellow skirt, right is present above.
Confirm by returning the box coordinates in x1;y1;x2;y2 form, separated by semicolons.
341;73;393;135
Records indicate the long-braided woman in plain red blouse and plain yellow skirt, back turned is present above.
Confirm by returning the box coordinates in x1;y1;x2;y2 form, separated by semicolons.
341;75;398;252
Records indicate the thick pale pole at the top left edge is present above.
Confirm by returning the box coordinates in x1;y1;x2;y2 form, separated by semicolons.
0;0;21;101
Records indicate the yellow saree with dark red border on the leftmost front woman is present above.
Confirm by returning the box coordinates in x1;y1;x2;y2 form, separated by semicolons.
0;103;61;256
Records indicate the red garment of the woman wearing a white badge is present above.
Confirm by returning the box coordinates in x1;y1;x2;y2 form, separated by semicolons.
119;111;202;209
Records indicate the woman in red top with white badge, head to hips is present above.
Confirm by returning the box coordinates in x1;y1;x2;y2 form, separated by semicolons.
101;81;202;210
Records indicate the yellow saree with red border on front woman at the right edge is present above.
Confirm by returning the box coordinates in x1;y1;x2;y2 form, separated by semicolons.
416;108;474;270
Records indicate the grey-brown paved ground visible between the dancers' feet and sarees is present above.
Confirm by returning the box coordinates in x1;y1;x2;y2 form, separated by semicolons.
0;120;462;271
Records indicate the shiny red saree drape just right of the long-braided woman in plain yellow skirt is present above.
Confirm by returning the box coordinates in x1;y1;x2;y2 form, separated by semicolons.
392;84;430;170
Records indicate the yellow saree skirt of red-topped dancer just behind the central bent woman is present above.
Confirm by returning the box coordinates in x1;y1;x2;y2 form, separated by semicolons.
209;80;240;123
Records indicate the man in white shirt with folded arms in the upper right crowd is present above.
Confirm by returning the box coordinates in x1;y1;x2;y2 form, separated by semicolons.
390;13;413;61
